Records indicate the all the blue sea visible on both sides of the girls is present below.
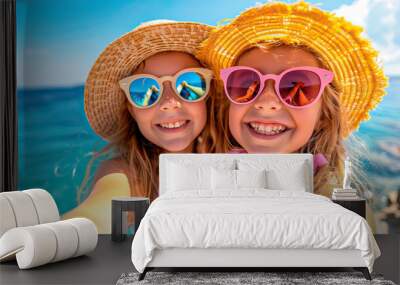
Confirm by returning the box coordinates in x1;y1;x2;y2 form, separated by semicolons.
17;78;400;213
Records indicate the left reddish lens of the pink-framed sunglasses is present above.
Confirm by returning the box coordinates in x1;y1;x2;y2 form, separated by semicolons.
226;70;260;103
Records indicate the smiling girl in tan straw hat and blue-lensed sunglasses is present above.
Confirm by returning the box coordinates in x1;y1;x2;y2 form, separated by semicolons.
66;20;216;233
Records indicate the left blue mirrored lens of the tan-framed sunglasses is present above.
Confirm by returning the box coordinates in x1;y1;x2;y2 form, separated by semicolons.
129;77;160;108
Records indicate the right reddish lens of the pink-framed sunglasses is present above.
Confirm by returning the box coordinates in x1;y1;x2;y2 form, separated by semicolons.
279;70;321;107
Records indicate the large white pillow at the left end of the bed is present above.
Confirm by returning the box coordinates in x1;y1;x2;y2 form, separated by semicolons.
167;163;211;191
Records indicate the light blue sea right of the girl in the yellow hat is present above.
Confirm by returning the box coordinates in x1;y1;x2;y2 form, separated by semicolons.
355;77;400;211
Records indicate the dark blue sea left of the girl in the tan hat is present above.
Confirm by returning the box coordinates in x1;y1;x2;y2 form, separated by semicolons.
17;86;106;214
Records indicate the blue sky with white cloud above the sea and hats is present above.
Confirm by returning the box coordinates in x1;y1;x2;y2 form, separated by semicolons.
17;0;400;88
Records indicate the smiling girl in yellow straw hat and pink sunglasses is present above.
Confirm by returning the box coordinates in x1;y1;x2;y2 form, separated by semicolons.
198;1;387;204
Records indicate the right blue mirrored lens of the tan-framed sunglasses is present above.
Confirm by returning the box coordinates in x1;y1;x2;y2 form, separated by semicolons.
175;71;207;101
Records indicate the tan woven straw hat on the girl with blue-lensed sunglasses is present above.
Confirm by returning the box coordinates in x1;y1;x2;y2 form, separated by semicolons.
84;20;212;140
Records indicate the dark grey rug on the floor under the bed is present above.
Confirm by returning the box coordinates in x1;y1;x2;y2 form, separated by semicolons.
117;271;395;285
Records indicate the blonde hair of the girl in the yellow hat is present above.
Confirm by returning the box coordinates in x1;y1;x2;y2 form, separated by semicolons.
216;41;366;197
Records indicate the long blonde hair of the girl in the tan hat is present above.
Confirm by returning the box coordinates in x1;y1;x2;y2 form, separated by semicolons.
77;55;217;203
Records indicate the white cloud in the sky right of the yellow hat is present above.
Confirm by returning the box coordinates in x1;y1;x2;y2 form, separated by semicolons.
333;0;400;75
